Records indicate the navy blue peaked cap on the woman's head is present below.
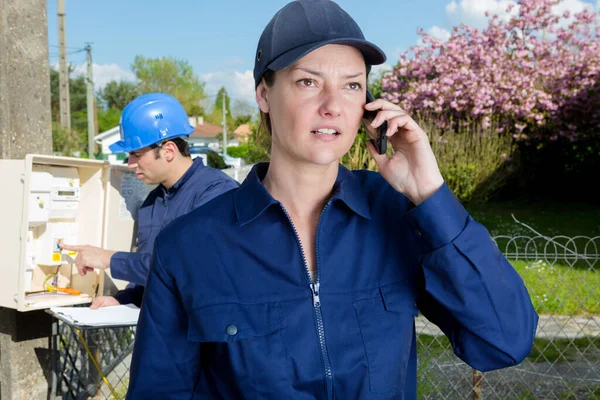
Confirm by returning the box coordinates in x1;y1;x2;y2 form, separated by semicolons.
254;0;386;87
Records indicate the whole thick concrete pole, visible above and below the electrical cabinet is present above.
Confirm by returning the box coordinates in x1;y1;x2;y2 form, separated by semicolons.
0;0;52;400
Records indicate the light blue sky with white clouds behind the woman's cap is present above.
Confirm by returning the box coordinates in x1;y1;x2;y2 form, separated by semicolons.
46;0;600;108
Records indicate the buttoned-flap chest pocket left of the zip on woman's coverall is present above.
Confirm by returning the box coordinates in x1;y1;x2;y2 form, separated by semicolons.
187;303;291;398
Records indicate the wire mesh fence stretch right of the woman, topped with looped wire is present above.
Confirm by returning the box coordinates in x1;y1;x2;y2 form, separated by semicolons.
416;235;600;400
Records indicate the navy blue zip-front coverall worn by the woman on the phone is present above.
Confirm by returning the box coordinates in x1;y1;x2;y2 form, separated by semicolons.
127;164;538;400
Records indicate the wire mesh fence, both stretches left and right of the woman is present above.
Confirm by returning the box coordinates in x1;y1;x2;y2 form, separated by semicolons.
52;235;600;400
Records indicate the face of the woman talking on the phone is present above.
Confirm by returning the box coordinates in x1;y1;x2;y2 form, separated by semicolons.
256;45;367;165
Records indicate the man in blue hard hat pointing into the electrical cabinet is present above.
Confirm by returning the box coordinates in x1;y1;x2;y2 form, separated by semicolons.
62;93;239;308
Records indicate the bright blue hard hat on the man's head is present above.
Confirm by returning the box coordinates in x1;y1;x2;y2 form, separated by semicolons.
108;93;194;153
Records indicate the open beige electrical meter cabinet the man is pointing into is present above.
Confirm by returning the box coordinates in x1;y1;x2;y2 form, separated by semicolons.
0;154;106;311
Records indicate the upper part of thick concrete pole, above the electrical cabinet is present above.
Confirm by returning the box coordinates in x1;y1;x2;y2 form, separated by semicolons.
0;0;52;159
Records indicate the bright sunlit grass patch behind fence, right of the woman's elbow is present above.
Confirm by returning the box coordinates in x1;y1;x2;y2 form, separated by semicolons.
513;260;600;316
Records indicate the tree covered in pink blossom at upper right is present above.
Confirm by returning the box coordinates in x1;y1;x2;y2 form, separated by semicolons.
382;0;600;142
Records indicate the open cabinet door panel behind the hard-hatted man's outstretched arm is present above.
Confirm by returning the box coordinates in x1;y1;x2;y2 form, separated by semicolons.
102;165;154;296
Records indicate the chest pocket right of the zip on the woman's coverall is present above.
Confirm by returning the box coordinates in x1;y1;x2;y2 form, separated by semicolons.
354;283;417;395
